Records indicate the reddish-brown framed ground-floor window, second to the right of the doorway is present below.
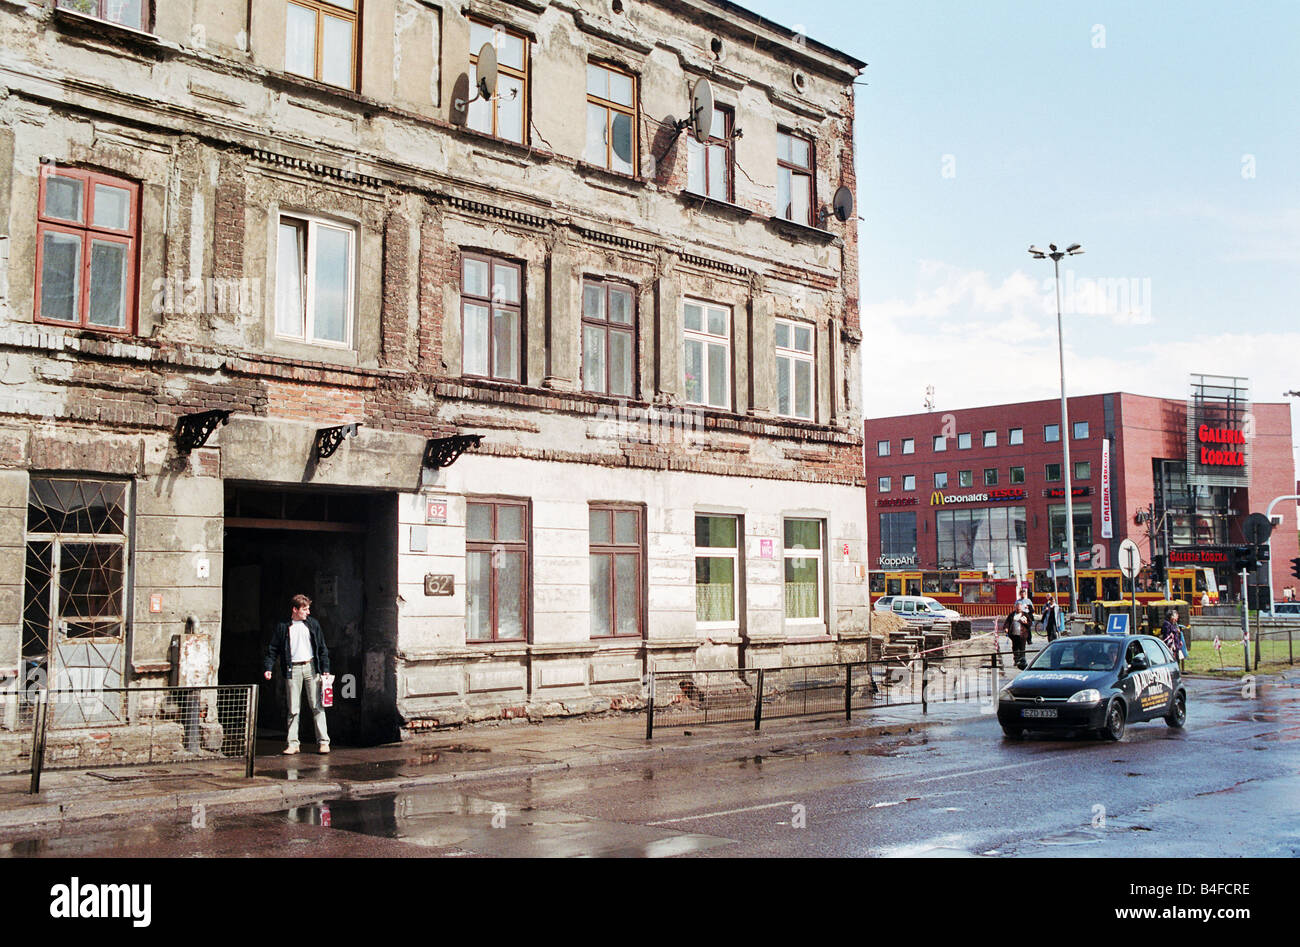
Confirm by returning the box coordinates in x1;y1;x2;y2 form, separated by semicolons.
588;503;645;637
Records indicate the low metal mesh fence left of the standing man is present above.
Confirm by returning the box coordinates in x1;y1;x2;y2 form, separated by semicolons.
0;684;257;792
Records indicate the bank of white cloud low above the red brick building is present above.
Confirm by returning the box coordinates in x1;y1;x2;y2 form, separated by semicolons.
862;261;1300;463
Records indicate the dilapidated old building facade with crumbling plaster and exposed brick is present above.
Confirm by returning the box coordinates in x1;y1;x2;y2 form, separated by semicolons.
0;0;867;740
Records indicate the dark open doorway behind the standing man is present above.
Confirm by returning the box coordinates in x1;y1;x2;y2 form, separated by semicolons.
217;487;398;745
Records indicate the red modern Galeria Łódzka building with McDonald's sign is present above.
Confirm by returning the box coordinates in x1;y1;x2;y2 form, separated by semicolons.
865;376;1297;601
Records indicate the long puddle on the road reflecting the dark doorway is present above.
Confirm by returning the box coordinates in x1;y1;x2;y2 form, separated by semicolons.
282;791;732;859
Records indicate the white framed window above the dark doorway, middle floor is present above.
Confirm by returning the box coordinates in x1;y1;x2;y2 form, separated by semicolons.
276;213;356;349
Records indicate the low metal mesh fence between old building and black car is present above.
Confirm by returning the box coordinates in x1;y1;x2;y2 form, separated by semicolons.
646;648;1014;739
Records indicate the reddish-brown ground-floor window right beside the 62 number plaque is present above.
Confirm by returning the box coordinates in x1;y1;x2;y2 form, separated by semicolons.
465;500;532;641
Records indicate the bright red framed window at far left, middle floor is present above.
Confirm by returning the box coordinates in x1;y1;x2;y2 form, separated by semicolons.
35;165;140;333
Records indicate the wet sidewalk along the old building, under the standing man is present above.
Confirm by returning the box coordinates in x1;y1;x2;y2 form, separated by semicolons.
0;701;987;838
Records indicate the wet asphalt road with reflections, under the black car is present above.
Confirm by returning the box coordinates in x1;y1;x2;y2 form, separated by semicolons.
0;674;1300;857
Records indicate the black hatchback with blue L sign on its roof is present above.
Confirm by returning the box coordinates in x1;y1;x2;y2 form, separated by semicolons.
997;635;1187;740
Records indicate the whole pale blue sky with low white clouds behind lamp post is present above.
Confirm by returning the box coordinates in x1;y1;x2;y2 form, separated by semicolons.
746;0;1300;465
